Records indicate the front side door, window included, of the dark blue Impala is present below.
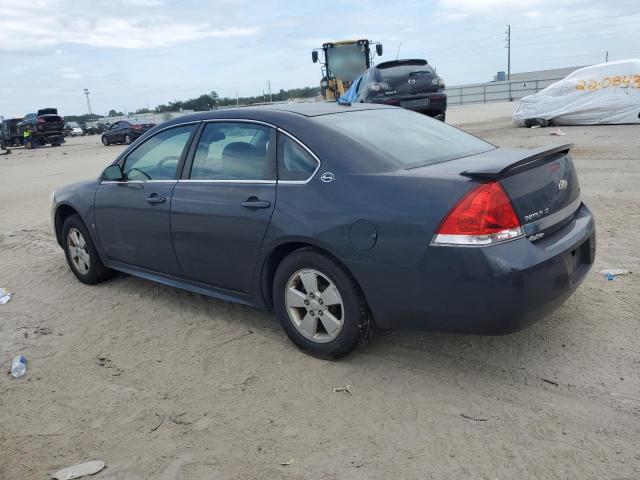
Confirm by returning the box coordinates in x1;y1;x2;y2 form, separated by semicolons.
95;124;197;275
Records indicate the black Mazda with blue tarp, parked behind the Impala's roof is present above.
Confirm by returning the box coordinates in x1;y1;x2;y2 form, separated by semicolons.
350;59;447;122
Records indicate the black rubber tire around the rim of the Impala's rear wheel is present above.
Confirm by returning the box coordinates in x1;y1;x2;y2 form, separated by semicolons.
273;248;375;359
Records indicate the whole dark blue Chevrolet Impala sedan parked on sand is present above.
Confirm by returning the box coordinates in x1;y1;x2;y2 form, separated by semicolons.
52;103;596;358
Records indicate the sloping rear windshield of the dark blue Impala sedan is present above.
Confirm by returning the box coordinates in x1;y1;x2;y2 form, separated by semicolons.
316;107;496;168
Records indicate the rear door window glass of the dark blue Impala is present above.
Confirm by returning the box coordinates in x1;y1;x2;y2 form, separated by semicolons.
190;122;275;181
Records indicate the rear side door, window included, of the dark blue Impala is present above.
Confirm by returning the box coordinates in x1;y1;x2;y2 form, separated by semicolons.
171;122;276;293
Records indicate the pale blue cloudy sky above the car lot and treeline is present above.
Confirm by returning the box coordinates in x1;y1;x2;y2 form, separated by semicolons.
0;0;640;116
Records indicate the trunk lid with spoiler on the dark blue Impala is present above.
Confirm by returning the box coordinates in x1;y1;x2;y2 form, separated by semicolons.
432;144;581;241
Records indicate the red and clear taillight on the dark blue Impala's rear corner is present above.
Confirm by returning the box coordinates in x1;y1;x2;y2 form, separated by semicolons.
432;182;522;245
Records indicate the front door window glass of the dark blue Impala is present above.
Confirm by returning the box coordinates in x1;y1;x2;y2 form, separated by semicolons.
124;125;195;180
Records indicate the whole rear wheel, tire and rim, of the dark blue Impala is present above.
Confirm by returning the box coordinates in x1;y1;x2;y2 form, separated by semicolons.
273;248;374;358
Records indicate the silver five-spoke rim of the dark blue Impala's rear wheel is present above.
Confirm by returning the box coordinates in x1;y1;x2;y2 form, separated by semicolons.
285;268;344;343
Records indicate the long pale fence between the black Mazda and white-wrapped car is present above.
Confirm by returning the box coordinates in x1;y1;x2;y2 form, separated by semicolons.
445;78;562;105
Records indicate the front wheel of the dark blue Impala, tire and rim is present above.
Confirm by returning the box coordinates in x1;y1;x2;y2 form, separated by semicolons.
62;215;112;285
